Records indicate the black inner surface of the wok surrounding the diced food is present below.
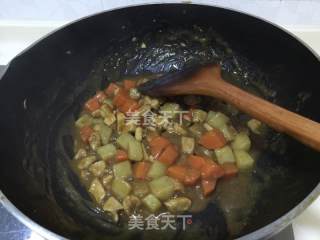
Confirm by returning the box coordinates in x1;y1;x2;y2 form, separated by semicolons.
0;5;320;239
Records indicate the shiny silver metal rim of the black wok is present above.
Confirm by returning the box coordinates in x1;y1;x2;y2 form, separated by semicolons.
0;1;320;240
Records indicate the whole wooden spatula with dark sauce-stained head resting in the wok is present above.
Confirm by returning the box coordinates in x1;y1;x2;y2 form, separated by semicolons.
139;65;320;151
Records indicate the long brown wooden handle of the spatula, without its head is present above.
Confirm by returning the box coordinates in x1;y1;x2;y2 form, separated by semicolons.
210;80;320;151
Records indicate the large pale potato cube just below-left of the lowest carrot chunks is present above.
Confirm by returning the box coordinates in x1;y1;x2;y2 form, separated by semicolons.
149;176;174;201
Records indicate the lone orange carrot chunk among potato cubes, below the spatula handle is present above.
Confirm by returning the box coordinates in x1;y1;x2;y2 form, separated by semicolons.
199;129;227;149
